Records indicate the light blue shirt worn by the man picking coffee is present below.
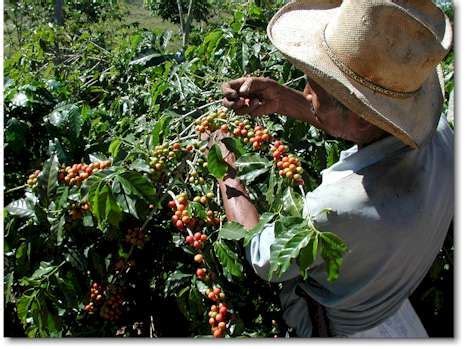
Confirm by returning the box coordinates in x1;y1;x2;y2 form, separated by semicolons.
246;117;454;337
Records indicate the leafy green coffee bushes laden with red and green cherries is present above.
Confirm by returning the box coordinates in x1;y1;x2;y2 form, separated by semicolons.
4;1;449;338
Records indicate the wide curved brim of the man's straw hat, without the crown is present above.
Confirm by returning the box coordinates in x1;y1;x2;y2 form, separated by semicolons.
267;0;444;148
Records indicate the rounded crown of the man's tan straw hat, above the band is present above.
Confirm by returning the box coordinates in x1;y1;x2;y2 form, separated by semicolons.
324;0;452;93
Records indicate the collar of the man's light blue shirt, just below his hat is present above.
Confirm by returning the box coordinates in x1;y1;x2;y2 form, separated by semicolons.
321;136;407;184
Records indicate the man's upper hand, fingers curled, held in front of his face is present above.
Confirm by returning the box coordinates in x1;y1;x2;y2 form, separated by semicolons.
222;77;284;116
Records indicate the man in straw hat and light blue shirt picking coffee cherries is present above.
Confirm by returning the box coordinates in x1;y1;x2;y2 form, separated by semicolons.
214;0;453;337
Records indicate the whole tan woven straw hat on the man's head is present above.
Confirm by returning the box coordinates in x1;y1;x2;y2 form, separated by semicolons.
267;0;452;148
